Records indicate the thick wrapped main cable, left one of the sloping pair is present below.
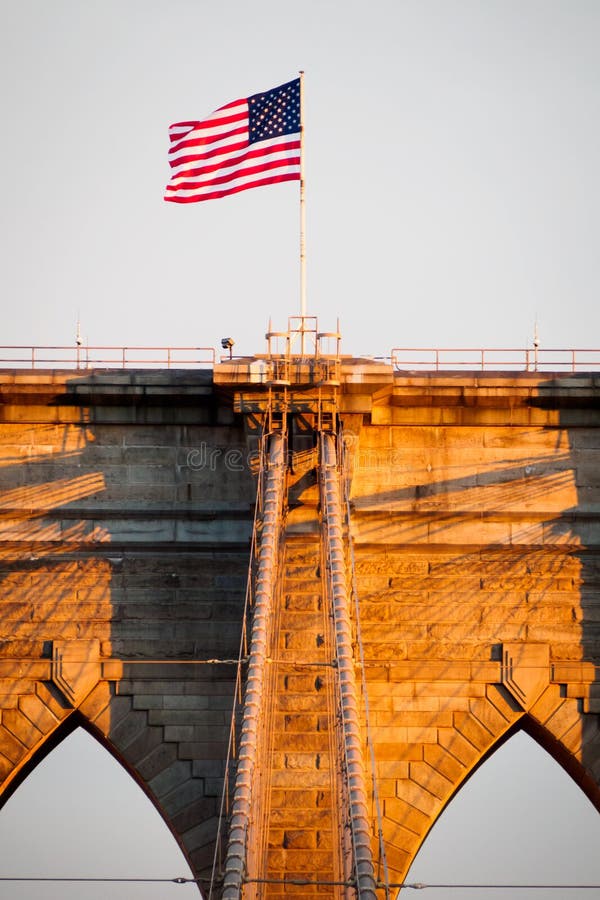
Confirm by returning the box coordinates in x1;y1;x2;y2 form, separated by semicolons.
222;434;285;900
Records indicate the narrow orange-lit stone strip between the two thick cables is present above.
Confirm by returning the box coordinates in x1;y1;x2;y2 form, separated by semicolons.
251;536;342;897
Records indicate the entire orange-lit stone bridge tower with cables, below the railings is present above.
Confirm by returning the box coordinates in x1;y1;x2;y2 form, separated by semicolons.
0;340;600;898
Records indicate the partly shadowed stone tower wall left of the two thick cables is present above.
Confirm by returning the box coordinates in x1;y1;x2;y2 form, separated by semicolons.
0;373;255;884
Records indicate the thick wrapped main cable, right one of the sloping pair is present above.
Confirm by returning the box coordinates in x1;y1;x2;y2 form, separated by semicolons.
321;434;377;900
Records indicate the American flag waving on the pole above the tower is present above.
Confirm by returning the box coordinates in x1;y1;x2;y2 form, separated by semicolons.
165;78;300;203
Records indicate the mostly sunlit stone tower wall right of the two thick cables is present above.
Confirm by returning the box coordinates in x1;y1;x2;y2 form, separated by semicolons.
352;378;600;880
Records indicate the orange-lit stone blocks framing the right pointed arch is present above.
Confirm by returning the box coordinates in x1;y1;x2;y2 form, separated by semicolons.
373;684;600;880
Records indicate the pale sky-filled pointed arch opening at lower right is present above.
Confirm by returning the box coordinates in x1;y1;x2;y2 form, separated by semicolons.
400;721;600;900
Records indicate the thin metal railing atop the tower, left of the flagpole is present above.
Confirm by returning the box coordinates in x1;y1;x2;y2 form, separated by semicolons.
0;345;216;369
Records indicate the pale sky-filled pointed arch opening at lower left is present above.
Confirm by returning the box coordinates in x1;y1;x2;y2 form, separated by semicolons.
0;716;202;900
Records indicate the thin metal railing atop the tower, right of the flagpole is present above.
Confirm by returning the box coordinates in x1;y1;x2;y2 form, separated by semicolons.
391;347;600;372
